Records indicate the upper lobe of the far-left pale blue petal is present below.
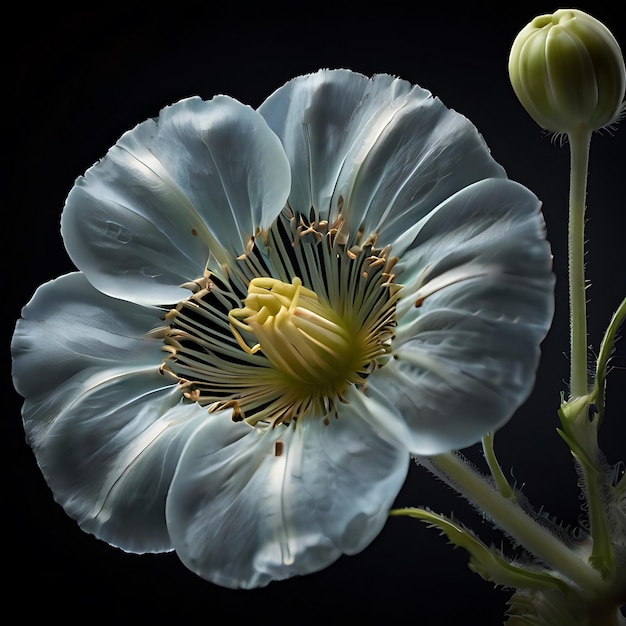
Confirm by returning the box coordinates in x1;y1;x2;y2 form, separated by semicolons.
11;273;164;444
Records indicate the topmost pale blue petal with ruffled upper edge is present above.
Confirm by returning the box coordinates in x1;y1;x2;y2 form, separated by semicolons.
259;70;505;246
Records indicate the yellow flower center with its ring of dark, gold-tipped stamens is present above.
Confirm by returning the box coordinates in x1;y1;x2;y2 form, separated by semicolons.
161;208;399;426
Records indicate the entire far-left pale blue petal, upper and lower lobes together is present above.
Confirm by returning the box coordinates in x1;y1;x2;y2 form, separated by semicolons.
11;273;206;552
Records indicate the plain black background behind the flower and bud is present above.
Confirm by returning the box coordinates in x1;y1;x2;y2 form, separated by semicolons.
6;1;626;626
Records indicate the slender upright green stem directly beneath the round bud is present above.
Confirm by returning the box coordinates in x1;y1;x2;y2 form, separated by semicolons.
568;126;591;398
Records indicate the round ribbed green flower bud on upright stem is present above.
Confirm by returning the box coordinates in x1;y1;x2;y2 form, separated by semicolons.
509;9;626;134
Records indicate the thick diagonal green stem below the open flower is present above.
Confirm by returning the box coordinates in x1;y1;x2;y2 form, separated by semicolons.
429;452;604;594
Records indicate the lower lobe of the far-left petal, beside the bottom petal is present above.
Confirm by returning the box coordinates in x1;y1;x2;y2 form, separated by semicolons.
31;368;207;552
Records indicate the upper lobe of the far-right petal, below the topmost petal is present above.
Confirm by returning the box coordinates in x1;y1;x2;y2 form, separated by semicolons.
395;179;555;330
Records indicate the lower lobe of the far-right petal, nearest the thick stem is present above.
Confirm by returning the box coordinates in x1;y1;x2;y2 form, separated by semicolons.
368;310;539;455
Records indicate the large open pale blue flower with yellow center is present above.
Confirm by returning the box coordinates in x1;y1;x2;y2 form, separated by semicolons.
12;70;553;588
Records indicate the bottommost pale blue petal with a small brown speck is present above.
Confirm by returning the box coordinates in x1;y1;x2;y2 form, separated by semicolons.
167;398;409;588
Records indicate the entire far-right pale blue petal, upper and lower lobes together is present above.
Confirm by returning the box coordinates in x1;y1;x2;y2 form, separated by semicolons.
369;179;554;454
